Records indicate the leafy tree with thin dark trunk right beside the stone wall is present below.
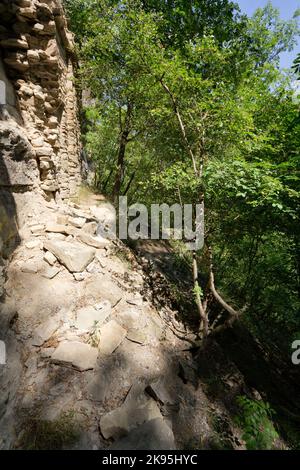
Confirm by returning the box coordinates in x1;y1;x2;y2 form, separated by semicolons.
69;0;164;201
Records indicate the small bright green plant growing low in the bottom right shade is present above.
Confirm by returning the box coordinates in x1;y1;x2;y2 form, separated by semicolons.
236;396;279;450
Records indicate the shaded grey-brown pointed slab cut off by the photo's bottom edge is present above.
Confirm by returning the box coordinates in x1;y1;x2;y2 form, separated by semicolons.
109;418;176;450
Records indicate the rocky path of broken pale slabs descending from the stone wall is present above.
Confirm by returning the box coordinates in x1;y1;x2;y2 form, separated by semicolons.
0;196;217;449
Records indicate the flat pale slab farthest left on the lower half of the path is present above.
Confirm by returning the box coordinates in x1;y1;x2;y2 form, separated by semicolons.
51;341;98;371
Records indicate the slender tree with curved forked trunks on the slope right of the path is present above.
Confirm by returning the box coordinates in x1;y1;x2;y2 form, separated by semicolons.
135;7;297;336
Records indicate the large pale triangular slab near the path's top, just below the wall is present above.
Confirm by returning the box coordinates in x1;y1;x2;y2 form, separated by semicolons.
44;240;95;273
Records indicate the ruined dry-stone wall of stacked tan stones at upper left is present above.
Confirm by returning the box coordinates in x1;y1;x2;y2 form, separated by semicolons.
0;0;81;199
